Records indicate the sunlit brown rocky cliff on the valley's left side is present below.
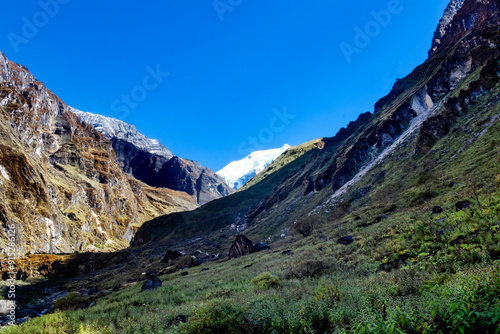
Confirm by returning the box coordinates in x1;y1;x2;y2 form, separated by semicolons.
0;53;196;254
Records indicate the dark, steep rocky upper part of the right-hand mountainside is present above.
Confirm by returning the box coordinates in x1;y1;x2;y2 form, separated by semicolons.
134;0;500;253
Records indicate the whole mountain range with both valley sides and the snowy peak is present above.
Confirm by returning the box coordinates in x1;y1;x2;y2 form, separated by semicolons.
0;0;500;334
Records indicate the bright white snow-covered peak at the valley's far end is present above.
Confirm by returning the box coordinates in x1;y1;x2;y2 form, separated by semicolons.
217;144;290;189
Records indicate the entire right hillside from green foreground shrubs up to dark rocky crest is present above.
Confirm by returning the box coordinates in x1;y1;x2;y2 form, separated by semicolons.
4;0;500;334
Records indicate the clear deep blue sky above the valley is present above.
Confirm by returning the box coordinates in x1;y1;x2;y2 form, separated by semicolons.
0;0;449;170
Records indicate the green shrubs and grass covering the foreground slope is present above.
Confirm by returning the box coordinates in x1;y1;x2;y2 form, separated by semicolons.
5;181;500;334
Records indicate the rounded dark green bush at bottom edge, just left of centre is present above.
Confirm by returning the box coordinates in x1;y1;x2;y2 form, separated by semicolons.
187;301;245;334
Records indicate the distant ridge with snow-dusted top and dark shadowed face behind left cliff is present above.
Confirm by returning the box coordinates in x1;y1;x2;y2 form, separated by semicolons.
72;109;233;204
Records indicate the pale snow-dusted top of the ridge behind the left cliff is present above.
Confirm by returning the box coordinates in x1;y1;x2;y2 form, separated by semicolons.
70;108;174;159
